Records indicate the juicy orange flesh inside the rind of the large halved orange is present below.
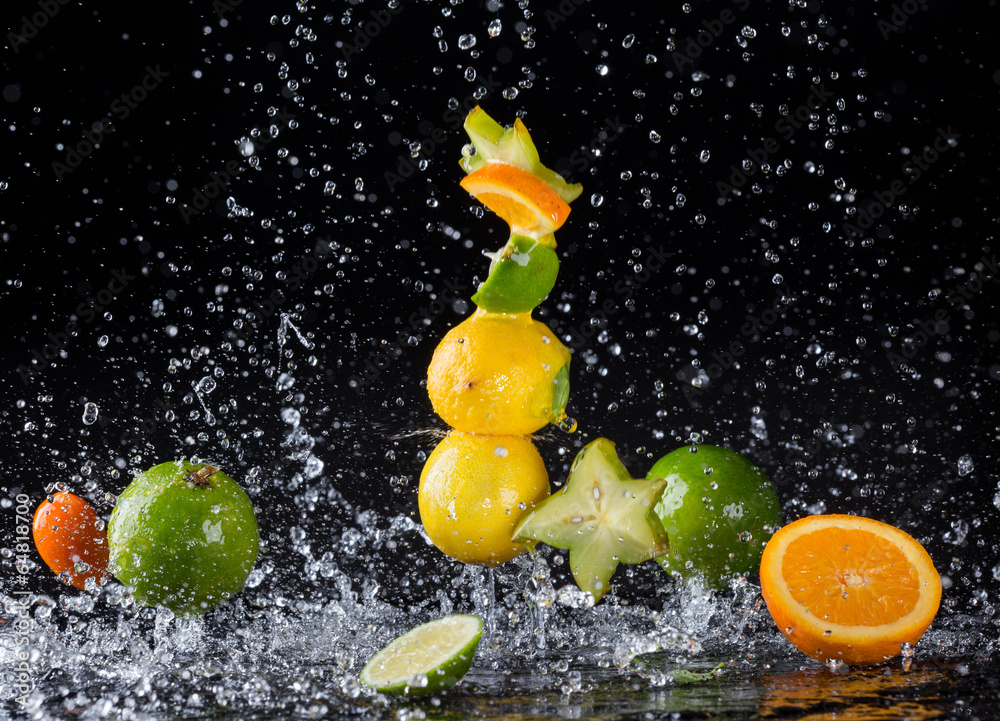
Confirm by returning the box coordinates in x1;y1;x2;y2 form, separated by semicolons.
781;527;920;626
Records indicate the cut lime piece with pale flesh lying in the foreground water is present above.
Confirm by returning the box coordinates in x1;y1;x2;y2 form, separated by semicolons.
359;614;483;695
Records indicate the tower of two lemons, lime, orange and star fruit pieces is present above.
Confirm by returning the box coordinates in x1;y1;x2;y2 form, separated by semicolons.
418;108;582;566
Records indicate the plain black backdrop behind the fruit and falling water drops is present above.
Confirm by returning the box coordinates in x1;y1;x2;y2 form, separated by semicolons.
0;0;1000;606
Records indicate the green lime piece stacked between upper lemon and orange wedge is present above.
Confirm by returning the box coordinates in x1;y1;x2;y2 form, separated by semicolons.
472;235;559;313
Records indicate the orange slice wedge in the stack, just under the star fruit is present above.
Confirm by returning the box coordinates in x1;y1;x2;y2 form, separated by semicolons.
461;161;569;239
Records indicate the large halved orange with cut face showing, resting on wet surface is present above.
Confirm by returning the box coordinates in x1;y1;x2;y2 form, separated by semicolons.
760;515;941;665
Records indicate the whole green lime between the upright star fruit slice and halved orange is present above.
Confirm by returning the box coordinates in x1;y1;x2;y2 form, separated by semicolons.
648;445;781;588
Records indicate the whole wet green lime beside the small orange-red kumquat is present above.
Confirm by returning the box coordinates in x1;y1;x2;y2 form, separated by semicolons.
108;461;259;615
